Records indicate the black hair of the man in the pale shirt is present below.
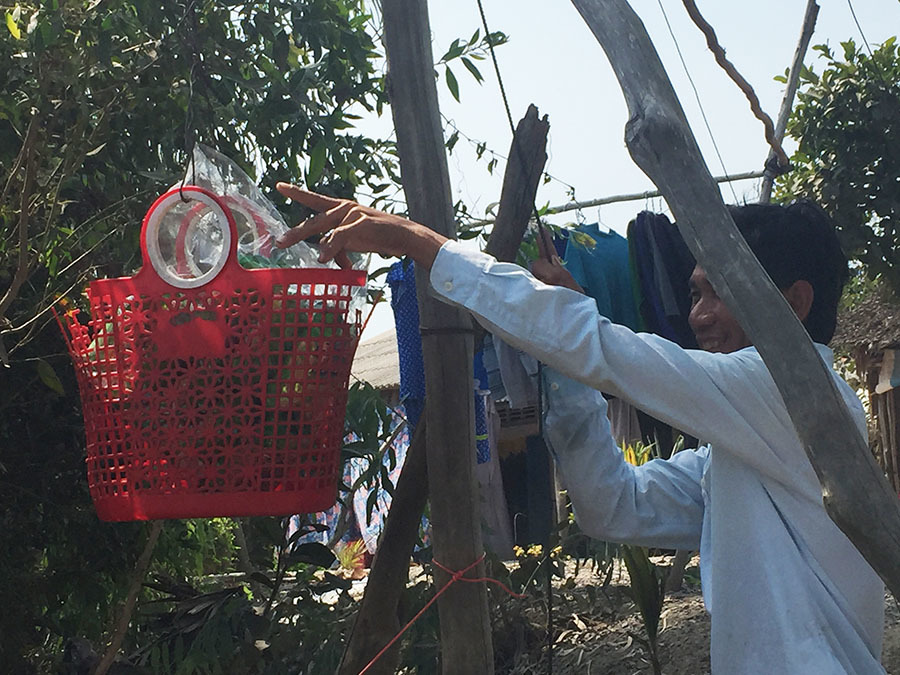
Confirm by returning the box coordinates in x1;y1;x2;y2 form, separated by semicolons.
729;200;849;344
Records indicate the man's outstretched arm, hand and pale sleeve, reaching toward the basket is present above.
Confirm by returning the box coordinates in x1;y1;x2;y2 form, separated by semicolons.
278;183;821;500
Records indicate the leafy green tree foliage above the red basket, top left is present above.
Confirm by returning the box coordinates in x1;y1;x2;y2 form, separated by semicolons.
0;0;392;360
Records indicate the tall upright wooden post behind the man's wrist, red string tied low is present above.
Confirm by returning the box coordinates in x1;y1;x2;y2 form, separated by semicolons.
382;0;494;675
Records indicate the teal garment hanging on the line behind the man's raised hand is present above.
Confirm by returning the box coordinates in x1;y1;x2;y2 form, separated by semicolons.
565;223;643;331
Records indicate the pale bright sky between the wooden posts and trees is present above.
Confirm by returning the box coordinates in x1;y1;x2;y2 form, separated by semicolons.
363;0;900;340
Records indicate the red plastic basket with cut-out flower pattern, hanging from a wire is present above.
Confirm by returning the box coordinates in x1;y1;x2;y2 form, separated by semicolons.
60;187;365;520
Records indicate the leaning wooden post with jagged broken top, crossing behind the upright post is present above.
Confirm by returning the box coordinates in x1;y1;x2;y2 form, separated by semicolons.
339;105;550;675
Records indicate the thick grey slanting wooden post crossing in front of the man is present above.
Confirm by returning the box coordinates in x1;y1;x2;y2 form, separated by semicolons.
572;0;900;598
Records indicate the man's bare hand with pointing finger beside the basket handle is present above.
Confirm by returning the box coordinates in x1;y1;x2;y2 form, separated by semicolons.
275;183;447;269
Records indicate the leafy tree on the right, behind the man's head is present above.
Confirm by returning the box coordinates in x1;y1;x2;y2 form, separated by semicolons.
776;38;900;290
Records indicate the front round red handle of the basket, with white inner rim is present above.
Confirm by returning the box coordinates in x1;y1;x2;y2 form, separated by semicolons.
141;185;238;288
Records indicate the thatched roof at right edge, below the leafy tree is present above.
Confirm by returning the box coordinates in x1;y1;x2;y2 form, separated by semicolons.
831;285;900;351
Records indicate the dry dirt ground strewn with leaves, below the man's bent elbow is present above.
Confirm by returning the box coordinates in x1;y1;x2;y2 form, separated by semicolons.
495;560;900;675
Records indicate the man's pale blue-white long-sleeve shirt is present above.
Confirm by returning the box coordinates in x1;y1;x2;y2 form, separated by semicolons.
431;242;884;675
